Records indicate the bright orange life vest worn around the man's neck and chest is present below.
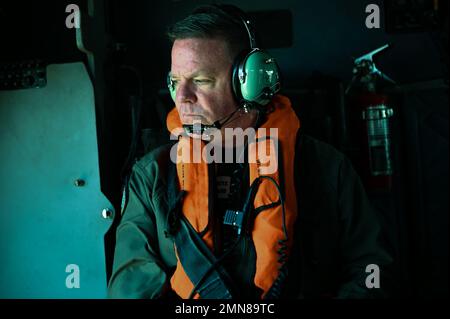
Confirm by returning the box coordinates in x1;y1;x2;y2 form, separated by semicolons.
167;95;300;298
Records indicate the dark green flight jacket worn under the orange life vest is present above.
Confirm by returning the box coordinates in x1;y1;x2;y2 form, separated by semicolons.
108;134;392;298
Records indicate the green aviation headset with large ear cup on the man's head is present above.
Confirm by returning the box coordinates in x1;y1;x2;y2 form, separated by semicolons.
167;5;281;110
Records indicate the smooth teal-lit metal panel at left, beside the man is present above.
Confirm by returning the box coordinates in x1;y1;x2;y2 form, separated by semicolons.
0;63;113;298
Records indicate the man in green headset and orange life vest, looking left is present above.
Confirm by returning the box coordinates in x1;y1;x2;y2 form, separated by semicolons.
108;6;390;299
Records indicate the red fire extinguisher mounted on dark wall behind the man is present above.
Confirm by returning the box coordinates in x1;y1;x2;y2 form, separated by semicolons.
346;45;395;191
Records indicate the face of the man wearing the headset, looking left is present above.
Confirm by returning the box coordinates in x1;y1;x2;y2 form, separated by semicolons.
171;38;237;124
